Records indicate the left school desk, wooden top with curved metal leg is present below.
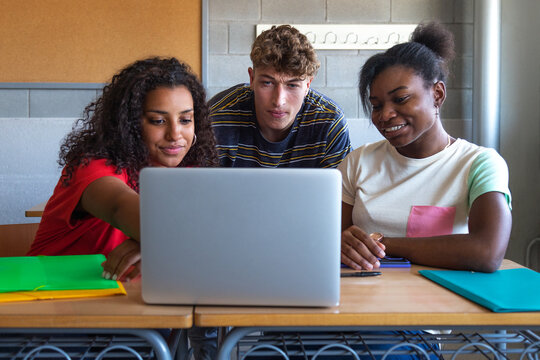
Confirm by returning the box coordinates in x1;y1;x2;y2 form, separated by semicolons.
0;280;193;360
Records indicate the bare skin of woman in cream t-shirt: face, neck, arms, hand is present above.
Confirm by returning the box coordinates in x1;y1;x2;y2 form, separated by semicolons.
341;66;512;272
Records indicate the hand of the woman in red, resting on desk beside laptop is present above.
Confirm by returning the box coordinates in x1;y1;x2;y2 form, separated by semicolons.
101;239;141;281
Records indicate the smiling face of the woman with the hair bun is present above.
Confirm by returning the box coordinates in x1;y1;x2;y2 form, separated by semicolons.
369;66;447;158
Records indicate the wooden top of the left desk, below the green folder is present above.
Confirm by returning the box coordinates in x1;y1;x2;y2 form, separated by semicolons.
0;280;193;328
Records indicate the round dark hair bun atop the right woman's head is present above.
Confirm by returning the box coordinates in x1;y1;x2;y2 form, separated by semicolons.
411;22;455;63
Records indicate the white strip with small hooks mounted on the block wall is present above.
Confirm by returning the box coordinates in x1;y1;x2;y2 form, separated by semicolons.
256;24;417;50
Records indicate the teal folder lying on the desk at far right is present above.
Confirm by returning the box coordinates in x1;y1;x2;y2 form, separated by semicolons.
419;268;540;312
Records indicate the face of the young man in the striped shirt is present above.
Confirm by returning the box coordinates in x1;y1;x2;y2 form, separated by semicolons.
248;67;311;142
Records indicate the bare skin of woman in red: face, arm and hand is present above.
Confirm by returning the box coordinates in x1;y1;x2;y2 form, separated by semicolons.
89;86;195;280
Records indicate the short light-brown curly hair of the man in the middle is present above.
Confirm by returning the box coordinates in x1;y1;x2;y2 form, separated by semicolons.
250;25;321;77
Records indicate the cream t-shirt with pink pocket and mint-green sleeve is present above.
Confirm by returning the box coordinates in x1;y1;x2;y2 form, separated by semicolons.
338;139;511;237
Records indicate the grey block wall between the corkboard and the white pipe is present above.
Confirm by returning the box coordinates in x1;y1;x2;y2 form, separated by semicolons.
207;0;474;147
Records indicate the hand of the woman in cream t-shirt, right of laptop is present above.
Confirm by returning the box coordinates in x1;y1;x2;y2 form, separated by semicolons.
341;225;386;270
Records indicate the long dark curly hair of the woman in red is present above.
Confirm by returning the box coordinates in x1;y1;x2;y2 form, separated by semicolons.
58;57;218;189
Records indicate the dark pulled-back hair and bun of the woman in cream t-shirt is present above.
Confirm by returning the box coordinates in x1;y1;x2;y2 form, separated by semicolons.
359;22;455;114
